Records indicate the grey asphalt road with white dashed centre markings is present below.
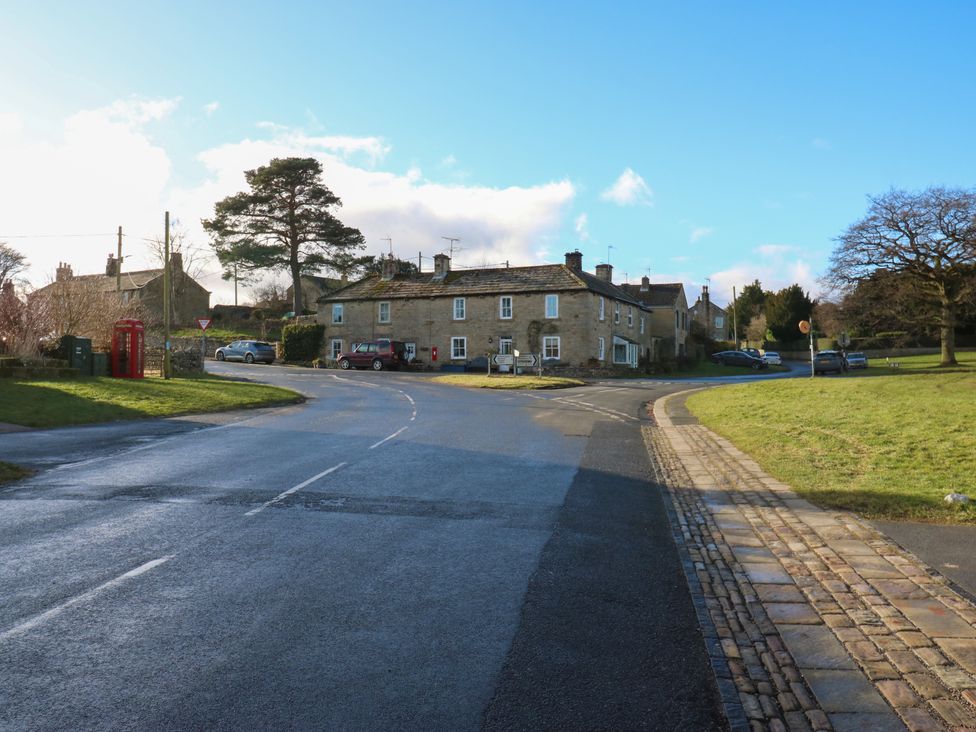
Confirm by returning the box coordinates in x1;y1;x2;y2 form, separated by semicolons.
0;364;724;730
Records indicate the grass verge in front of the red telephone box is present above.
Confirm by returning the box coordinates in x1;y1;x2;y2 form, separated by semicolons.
0;376;302;427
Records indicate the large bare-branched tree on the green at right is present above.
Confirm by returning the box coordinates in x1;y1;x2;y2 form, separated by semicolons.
825;188;976;366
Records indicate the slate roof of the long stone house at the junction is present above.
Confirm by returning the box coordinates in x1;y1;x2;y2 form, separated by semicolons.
318;264;641;306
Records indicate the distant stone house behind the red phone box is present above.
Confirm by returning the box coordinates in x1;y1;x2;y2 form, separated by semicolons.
34;252;210;326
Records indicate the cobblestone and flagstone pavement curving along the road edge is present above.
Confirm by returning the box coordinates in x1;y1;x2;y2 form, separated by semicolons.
644;392;976;732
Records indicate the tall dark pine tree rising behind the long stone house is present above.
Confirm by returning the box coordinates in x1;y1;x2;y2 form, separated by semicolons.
203;158;364;313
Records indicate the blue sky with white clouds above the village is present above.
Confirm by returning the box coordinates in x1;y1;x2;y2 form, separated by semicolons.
0;0;976;304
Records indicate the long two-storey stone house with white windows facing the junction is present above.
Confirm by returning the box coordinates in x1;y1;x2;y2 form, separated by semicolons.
318;252;657;370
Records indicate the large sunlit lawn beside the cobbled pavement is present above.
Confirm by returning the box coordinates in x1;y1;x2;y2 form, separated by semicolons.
688;368;976;523
